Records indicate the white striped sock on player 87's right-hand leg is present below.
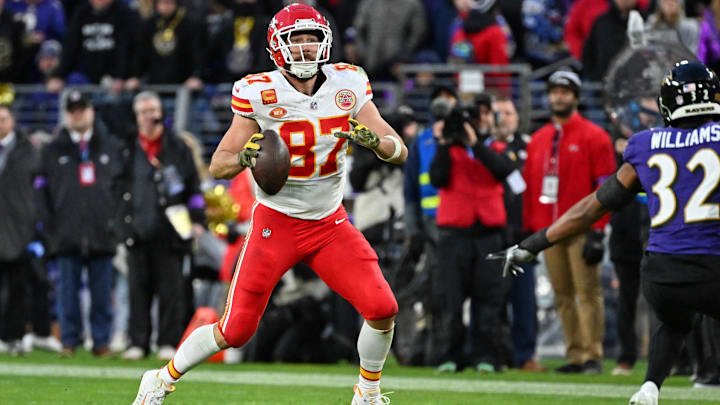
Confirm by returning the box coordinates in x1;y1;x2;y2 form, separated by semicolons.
358;322;395;392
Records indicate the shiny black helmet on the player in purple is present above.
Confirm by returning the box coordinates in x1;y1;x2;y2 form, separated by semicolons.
657;61;720;127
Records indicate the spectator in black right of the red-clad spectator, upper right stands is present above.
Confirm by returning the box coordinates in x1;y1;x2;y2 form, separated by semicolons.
581;0;638;82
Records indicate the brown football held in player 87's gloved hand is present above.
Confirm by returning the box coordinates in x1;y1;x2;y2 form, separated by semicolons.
252;129;290;195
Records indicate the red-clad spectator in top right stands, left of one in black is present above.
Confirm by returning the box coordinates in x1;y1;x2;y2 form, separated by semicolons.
565;0;650;60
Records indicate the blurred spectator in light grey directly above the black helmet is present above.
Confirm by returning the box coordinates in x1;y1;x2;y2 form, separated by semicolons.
645;0;700;53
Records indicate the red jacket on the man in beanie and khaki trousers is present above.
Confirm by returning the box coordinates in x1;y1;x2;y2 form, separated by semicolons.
523;112;616;232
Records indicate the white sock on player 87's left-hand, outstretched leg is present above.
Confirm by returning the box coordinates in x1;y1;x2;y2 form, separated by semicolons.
160;324;220;385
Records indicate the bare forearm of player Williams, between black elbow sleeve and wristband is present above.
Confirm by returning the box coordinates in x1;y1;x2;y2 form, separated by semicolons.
547;193;608;243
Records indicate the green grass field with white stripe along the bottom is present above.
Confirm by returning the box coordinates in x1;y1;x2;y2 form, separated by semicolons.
0;351;720;405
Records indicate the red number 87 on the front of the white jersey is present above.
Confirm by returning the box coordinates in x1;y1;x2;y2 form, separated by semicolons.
279;115;350;179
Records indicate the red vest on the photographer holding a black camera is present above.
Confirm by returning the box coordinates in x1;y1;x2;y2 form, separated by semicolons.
436;146;507;228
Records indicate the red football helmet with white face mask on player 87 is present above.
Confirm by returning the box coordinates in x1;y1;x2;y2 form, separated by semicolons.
268;3;332;79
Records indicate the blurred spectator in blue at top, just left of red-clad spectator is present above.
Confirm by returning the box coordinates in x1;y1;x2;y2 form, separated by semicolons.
522;0;570;67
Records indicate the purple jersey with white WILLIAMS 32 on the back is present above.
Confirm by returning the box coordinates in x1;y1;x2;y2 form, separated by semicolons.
624;122;720;255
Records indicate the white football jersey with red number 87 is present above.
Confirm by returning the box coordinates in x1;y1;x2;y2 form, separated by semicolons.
232;63;372;219
